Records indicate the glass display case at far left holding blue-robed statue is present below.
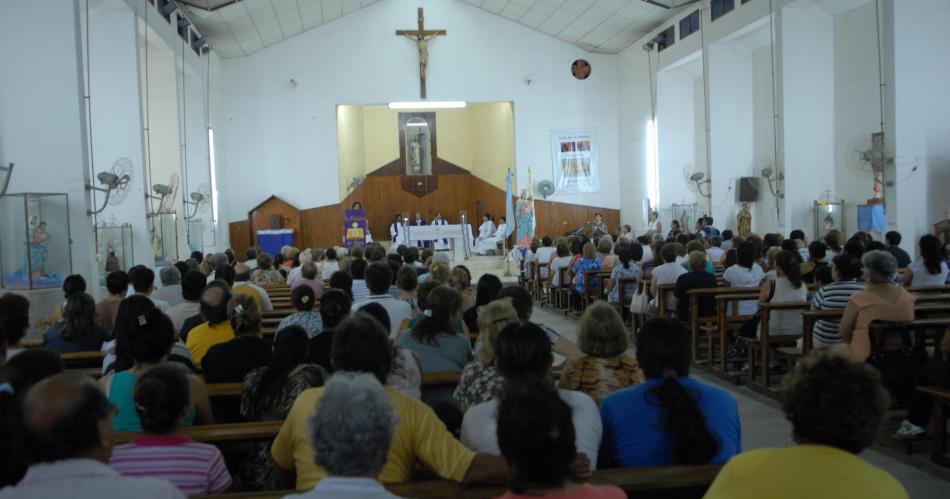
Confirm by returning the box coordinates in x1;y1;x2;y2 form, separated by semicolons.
0;193;72;289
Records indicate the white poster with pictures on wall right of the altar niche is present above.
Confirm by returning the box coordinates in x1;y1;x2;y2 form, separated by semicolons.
551;128;600;194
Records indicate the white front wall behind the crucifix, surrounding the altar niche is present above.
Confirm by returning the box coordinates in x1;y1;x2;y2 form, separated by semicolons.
212;0;620;230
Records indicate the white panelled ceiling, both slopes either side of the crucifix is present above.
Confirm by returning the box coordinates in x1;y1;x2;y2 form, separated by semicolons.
178;0;681;58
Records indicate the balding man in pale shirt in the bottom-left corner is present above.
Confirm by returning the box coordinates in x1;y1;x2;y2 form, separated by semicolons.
0;373;185;499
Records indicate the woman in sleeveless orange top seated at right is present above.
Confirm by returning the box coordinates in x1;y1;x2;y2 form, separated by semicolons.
839;251;915;361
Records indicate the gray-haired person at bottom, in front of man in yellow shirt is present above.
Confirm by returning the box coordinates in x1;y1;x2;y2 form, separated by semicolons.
287;372;399;499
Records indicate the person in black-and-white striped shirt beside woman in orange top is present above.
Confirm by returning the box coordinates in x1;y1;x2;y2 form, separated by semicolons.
811;253;864;348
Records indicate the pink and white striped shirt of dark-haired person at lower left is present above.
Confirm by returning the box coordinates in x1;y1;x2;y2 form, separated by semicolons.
109;435;231;496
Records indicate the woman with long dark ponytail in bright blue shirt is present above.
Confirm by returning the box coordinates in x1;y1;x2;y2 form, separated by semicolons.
600;319;742;468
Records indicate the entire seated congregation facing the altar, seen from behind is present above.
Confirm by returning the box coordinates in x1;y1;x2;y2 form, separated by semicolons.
0;229;950;499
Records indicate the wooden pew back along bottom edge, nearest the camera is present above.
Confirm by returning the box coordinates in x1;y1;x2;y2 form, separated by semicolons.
206;464;721;499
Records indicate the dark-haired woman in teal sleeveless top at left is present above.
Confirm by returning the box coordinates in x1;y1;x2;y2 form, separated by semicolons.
99;308;213;431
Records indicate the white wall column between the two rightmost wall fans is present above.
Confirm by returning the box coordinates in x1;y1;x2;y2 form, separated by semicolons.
781;0;835;236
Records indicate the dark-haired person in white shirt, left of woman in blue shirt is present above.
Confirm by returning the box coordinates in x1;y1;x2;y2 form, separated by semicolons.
461;322;603;470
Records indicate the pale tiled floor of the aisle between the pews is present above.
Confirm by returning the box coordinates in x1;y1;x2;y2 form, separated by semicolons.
531;305;950;499
